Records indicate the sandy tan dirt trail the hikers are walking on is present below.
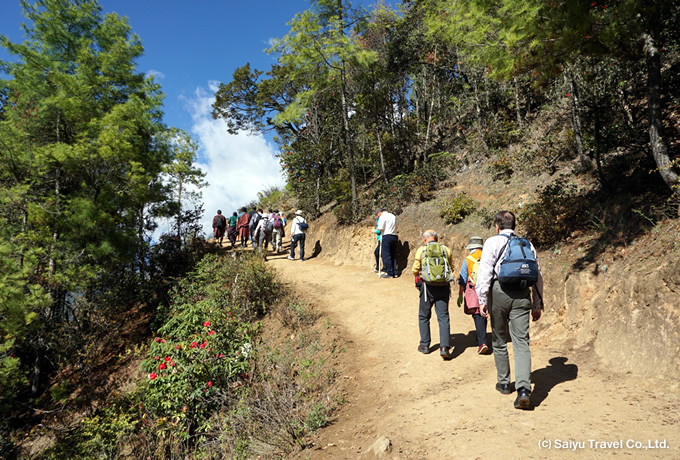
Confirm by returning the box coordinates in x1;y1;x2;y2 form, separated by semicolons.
269;252;680;459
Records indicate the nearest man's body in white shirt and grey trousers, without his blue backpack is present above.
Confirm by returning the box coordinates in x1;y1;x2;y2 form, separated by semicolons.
477;211;543;409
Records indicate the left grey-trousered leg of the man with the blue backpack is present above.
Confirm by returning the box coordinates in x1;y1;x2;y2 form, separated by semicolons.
488;282;512;383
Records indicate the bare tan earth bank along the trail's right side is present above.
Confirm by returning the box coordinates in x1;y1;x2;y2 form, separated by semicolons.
307;161;680;377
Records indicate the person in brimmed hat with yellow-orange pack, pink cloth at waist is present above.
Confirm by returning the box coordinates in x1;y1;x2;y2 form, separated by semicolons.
457;236;489;355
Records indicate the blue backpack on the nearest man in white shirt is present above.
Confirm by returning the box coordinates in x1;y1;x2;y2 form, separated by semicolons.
494;233;538;290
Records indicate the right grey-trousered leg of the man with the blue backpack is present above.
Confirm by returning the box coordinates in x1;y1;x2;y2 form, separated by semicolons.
509;293;531;390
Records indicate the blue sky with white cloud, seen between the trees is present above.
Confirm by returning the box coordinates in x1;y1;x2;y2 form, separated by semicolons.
0;0;330;233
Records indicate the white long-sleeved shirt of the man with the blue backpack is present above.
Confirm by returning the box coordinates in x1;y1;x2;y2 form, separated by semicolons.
475;230;543;308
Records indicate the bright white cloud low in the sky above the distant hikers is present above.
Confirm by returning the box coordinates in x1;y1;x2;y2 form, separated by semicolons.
186;82;284;236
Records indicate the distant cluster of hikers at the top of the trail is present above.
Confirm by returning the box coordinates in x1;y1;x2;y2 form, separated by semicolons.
212;207;309;260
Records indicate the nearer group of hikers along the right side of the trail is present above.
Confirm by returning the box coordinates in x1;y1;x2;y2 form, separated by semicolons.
375;208;543;409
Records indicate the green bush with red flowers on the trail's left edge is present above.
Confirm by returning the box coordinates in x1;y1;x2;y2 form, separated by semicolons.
137;252;270;439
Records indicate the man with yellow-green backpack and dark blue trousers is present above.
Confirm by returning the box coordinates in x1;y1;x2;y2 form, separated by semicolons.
412;230;454;360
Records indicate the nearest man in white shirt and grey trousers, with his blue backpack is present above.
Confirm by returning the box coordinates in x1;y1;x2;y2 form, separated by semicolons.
476;211;543;409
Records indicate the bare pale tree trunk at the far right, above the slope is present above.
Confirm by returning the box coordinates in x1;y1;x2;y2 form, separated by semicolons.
642;33;680;194
